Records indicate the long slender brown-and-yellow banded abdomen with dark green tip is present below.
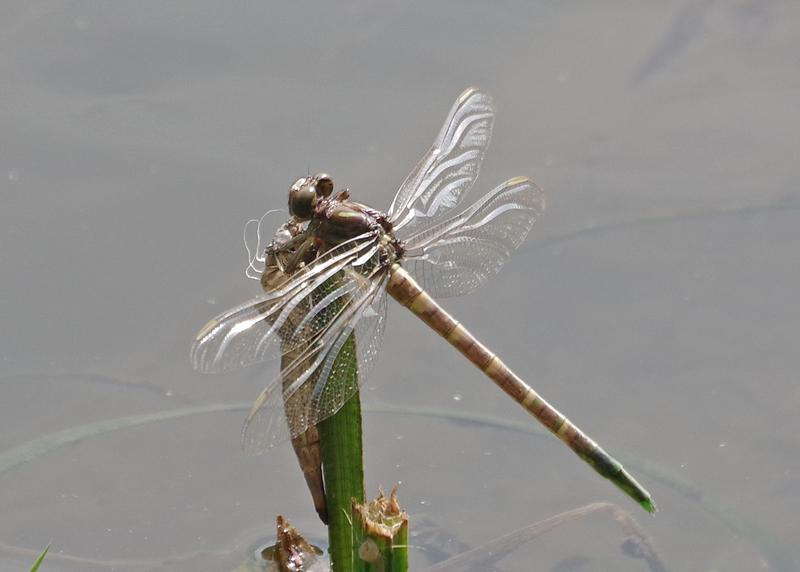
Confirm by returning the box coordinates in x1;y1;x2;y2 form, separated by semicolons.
386;264;656;512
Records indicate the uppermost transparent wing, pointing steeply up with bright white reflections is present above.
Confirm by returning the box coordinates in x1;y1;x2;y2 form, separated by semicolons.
388;88;494;238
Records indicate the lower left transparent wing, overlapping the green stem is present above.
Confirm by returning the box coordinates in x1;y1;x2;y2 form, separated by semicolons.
242;267;388;454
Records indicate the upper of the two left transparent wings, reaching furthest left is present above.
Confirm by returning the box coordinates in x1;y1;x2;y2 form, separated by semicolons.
191;233;378;373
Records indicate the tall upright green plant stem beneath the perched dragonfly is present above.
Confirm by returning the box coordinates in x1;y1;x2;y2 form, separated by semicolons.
318;335;365;572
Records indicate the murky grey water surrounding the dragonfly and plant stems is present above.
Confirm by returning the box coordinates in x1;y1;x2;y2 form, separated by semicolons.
0;0;800;572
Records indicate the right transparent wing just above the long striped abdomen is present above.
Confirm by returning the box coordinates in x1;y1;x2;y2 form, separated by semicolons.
403;177;544;298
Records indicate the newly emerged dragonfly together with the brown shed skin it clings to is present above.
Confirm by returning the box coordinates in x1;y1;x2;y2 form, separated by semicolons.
191;88;655;521
